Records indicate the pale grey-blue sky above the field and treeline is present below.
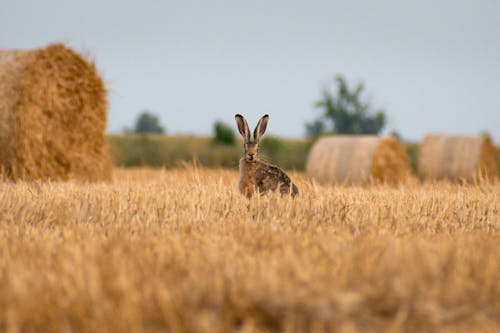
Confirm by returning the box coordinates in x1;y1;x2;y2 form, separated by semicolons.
0;0;500;142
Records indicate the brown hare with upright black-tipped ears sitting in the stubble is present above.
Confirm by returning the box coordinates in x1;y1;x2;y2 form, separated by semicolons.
235;114;299;198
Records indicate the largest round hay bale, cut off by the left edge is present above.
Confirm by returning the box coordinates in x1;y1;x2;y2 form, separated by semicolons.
0;44;111;181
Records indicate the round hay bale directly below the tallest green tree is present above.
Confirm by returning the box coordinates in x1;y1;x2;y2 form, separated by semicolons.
306;136;409;185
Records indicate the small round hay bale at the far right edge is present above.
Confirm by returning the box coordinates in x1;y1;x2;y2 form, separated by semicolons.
418;134;496;181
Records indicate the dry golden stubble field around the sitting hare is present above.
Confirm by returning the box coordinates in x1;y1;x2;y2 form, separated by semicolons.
0;168;500;332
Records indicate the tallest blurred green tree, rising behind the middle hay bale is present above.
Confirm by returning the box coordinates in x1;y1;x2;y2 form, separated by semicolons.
306;75;386;136
